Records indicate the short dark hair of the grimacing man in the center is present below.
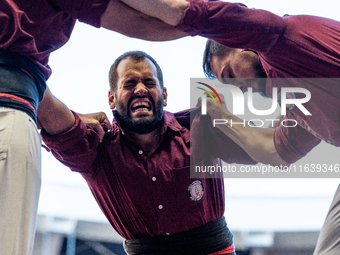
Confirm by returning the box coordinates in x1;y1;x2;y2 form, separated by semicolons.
109;51;164;92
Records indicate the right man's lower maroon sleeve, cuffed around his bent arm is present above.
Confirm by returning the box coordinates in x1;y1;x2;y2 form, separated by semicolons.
274;117;321;164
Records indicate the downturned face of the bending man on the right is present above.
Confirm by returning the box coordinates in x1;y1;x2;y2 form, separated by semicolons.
210;49;266;96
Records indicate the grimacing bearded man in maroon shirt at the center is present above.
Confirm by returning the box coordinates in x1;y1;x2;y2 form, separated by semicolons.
38;52;254;255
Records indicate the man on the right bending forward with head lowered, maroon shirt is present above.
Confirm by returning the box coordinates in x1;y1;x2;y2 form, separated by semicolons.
103;0;340;255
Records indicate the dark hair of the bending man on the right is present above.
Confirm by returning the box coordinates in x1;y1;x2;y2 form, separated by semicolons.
203;40;234;79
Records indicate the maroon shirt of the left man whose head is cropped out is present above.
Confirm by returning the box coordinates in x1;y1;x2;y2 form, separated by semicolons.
0;0;109;78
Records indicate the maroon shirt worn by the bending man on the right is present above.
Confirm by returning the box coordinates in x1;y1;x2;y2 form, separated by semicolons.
178;0;340;163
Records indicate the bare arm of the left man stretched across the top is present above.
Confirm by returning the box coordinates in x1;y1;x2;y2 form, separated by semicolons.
101;0;187;41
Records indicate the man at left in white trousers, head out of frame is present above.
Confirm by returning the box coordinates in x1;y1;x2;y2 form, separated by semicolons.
0;0;186;255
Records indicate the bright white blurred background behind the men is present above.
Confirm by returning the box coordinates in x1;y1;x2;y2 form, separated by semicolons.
34;0;340;255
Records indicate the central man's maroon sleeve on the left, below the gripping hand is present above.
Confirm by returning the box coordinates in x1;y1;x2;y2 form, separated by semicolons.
41;113;100;172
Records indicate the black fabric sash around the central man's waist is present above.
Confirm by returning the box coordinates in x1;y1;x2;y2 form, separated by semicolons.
124;217;233;255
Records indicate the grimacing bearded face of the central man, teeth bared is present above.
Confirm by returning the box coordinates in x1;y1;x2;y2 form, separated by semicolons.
109;57;167;134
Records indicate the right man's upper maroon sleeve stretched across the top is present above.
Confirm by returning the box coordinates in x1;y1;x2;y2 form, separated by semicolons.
177;0;285;51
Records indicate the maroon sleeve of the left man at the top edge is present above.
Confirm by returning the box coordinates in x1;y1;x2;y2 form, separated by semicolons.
52;0;110;27
